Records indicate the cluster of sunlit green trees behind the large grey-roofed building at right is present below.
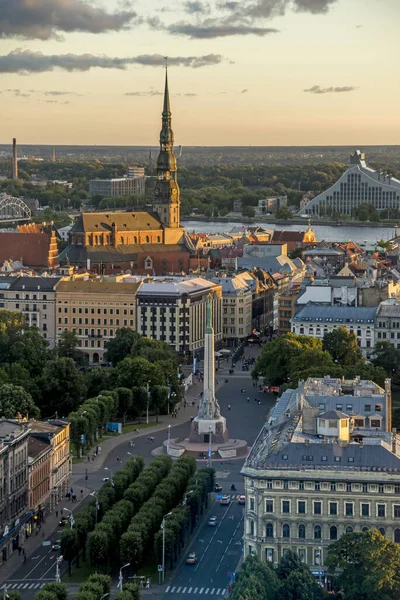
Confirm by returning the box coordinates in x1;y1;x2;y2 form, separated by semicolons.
252;327;388;386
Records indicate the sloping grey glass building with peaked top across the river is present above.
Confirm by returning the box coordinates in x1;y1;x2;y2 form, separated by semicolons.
300;150;400;216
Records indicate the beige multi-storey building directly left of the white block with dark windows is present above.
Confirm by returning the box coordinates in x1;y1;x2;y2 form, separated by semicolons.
56;275;140;364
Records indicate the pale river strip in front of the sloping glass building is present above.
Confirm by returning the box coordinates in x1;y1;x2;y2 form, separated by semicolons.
182;220;395;244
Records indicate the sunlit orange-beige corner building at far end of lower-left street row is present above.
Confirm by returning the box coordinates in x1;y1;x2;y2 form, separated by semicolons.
29;419;72;510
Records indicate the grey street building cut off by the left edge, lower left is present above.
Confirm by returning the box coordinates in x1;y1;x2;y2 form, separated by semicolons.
0;417;30;564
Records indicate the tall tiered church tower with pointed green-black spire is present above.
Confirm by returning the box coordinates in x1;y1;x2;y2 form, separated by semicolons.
154;67;181;230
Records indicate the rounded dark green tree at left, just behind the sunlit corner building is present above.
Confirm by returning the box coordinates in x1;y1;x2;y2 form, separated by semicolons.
40;358;86;416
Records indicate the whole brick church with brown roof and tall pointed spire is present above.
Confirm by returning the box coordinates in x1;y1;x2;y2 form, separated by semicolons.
59;71;208;275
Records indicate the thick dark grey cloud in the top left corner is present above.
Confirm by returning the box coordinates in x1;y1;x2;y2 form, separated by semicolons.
0;0;136;40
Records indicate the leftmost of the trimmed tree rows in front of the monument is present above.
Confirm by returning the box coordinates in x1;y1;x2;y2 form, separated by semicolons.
60;456;147;573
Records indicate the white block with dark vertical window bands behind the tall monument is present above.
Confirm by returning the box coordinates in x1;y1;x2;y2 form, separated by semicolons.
136;277;223;358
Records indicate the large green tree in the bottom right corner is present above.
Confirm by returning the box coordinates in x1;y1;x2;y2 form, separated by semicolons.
325;529;400;600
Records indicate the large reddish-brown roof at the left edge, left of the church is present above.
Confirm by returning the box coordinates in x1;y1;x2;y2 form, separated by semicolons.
0;233;51;267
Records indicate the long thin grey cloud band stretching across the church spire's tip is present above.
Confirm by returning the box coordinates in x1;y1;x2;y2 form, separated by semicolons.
0;48;223;74
